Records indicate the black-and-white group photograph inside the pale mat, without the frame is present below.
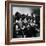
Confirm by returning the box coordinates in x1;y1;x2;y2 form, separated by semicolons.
11;6;40;38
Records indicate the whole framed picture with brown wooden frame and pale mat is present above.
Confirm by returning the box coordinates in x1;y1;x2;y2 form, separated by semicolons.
5;1;45;45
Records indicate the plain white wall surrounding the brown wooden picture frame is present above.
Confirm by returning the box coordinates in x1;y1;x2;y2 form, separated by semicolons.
0;0;46;46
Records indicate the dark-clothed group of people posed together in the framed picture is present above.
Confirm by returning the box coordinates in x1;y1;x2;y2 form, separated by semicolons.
13;12;39;38
